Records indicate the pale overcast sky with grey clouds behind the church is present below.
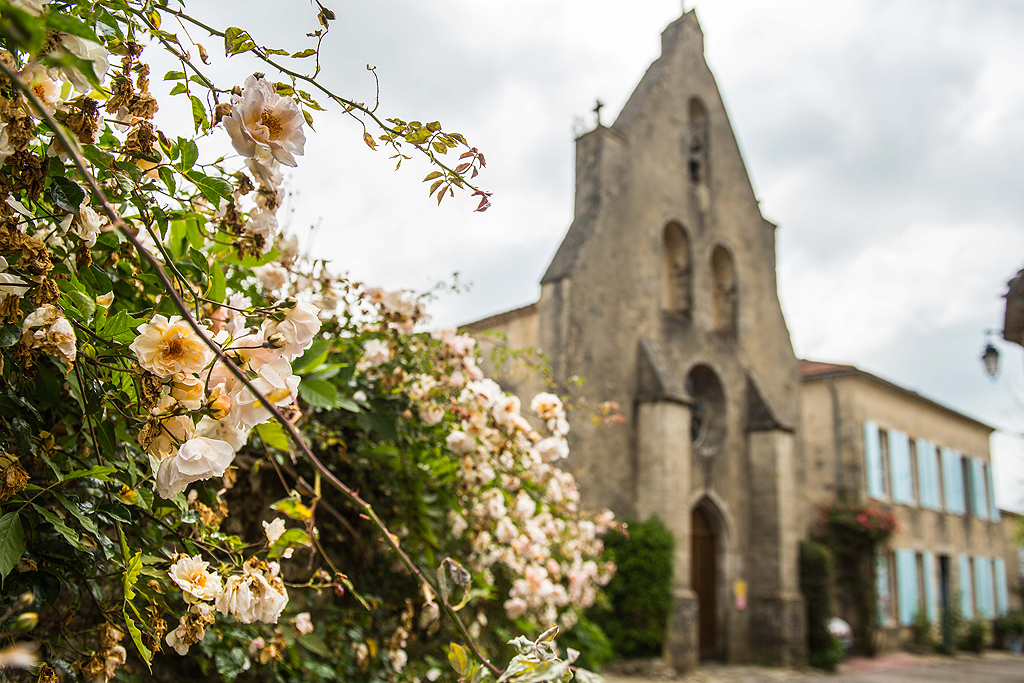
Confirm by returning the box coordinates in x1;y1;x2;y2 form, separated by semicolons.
165;0;1024;506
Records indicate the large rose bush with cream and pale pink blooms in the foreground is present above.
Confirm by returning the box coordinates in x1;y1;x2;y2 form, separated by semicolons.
0;0;614;681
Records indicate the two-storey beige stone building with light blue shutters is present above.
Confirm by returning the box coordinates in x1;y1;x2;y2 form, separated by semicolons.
797;360;1021;645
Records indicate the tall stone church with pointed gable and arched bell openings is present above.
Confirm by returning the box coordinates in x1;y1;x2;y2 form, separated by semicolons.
468;11;1019;669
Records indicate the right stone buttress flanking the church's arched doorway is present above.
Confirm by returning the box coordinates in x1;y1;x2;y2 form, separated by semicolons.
748;429;807;666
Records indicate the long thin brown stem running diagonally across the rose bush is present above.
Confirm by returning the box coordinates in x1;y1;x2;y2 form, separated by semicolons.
0;61;502;675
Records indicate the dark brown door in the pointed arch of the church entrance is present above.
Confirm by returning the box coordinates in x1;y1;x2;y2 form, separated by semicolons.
690;494;733;659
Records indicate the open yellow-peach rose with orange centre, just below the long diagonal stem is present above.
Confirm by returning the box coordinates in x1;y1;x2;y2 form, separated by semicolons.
131;313;215;378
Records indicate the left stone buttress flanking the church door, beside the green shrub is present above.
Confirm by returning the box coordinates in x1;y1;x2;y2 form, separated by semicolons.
637;399;698;671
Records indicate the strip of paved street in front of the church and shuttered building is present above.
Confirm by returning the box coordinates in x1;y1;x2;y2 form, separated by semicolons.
605;652;1024;683
